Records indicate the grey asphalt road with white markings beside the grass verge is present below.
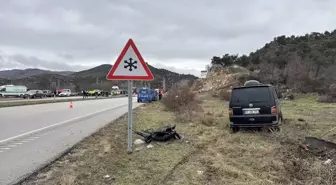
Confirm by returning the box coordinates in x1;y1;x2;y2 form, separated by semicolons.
0;98;140;185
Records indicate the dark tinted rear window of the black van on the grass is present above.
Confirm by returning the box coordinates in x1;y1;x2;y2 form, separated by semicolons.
231;87;271;103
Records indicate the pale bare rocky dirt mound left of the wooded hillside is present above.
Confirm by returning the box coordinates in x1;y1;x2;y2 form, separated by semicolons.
195;65;258;95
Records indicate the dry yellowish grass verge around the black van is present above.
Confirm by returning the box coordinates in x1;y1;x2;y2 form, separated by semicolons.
23;94;336;185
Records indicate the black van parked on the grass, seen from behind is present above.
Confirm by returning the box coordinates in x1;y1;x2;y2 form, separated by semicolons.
229;84;283;132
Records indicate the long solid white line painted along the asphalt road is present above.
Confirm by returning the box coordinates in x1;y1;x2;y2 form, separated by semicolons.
0;104;128;143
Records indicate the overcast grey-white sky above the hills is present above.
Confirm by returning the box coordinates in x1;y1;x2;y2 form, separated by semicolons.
0;0;336;76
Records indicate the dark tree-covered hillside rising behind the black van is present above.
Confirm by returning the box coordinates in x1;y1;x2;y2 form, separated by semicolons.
211;30;336;93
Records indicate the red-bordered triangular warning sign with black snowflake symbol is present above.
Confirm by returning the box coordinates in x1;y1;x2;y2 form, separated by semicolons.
106;39;154;80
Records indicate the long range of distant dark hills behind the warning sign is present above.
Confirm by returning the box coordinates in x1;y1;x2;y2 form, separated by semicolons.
0;64;197;91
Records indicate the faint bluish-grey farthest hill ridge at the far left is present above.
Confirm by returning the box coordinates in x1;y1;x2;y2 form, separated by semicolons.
0;68;73;78
